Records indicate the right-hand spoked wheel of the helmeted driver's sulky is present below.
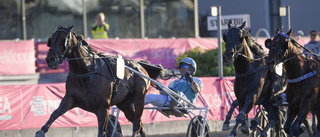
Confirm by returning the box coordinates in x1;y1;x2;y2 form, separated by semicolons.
187;115;210;137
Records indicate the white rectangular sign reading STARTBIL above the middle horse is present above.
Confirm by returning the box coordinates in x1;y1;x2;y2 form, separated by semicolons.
207;14;250;31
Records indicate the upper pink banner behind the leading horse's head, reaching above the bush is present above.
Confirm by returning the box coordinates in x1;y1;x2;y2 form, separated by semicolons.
36;38;218;73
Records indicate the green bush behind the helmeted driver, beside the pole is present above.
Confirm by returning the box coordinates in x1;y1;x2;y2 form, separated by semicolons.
176;43;235;77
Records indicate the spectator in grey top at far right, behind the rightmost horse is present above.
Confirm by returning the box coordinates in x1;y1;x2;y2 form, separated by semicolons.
304;30;320;58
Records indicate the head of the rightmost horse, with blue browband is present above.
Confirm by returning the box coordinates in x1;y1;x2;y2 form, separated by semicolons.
265;28;294;67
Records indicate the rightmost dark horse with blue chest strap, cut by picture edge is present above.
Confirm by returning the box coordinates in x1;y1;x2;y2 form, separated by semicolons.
265;28;320;137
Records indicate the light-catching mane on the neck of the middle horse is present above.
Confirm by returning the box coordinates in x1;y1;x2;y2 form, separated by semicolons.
243;30;266;57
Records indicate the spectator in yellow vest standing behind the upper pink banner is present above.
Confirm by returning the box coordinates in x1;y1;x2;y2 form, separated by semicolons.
91;12;110;39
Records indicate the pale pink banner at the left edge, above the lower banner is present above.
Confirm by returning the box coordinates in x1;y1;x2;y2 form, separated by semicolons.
0;40;36;75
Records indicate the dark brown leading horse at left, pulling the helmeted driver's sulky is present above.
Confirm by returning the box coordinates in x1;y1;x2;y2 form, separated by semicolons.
36;25;162;137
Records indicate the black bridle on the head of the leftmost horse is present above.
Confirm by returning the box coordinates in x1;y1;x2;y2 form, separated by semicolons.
47;27;72;64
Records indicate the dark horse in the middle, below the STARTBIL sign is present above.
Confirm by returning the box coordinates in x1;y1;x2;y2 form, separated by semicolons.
223;21;283;137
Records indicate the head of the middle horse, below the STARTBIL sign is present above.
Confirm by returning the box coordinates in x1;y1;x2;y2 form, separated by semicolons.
223;21;252;64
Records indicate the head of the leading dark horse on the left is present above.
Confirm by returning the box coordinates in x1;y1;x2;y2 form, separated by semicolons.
46;25;77;69
